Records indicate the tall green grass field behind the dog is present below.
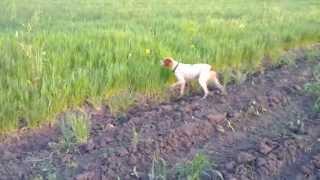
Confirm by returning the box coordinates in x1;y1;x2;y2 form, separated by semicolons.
0;0;320;132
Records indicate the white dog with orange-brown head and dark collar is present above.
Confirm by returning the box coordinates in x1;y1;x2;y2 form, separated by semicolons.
161;57;226;99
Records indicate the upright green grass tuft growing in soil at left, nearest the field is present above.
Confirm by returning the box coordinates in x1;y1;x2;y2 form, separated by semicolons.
59;113;90;150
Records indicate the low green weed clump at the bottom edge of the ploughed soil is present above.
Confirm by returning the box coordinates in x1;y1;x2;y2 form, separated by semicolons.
176;153;224;180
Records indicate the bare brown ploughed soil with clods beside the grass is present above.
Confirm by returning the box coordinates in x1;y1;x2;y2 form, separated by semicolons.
0;48;320;180
